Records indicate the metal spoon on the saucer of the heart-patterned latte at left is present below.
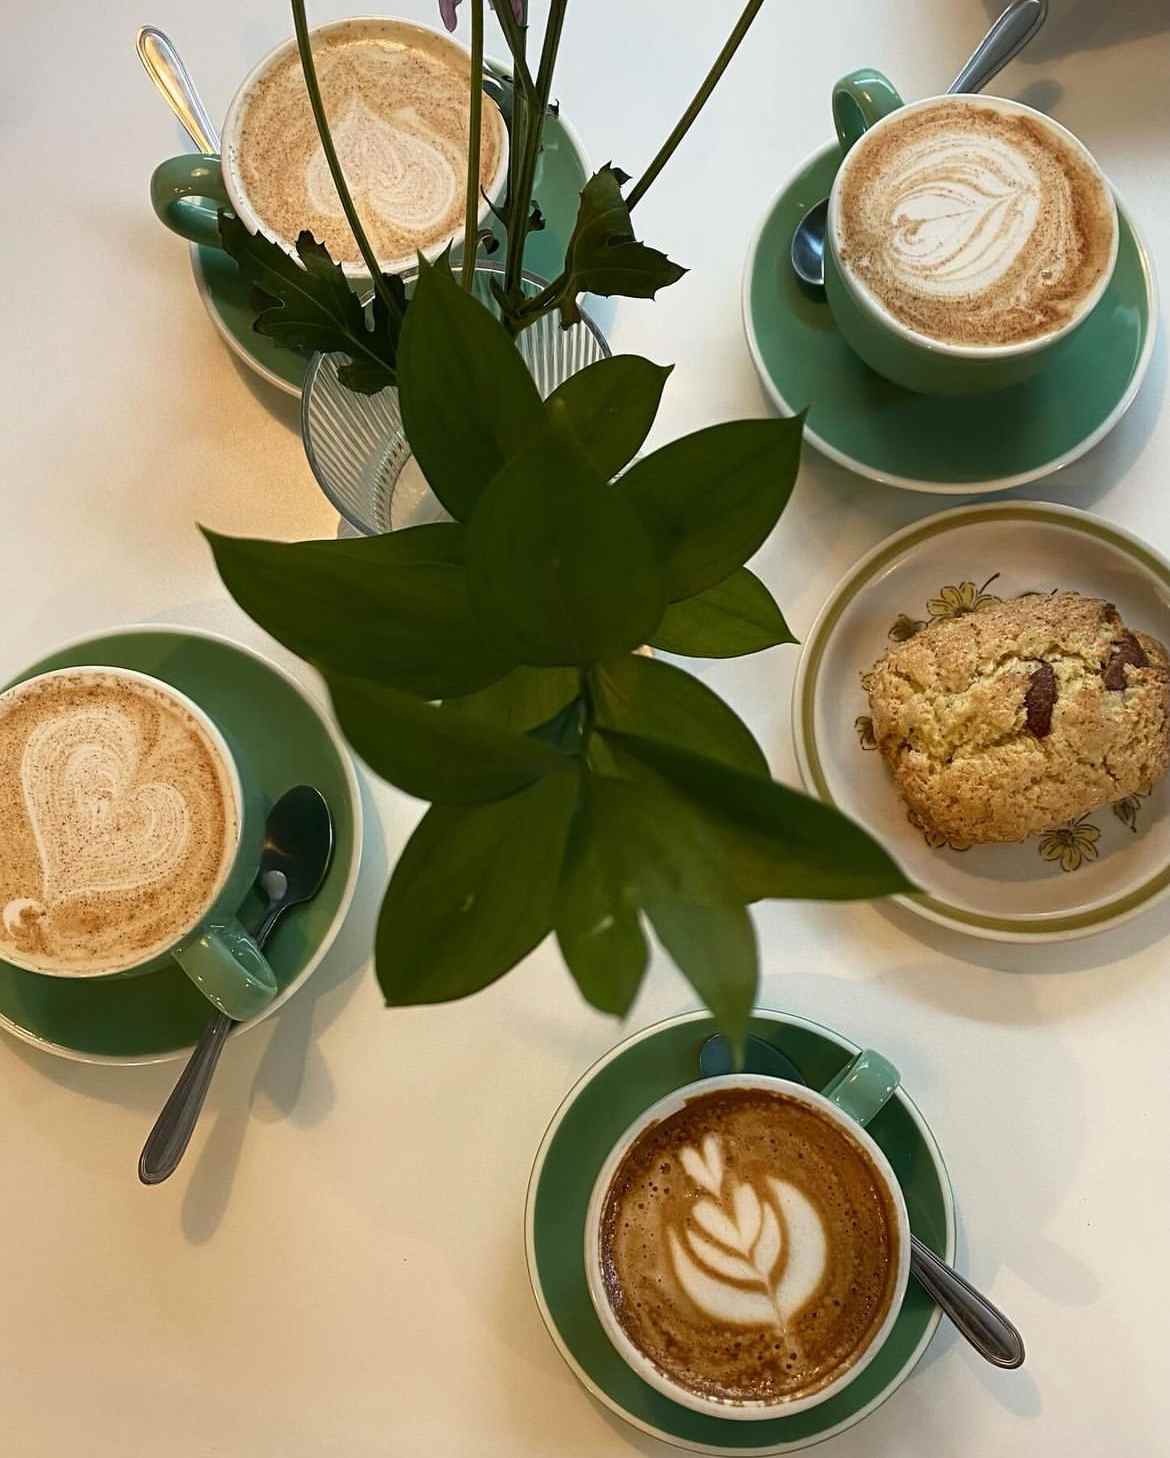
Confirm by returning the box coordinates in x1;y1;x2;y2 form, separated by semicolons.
139;784;333;1184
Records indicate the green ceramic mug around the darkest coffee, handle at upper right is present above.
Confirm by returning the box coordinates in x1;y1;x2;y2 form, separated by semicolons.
585;1048;910;1417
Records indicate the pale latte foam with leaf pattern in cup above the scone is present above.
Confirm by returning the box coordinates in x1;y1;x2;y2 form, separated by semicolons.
836;102;1116;346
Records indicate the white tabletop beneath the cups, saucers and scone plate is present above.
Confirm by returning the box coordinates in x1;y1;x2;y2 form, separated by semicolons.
0;0;1170;1458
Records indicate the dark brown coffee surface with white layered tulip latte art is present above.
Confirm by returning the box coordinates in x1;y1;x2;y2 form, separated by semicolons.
600;1089;899;1403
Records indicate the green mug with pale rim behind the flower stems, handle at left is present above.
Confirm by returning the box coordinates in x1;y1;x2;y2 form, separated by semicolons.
150;19;508;283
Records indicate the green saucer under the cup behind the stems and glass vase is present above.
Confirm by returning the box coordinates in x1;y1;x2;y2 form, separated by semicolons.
191;117;589;395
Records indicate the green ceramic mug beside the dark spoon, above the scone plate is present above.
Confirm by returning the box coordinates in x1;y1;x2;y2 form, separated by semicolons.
824;67;1117;395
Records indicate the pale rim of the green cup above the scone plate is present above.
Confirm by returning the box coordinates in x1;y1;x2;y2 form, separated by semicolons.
829;92;1120;360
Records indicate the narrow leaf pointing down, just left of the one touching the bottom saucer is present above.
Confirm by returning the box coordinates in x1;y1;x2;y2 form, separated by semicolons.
556;776;648;1018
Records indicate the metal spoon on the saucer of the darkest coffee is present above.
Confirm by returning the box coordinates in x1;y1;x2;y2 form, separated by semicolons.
699;1032;1024;1368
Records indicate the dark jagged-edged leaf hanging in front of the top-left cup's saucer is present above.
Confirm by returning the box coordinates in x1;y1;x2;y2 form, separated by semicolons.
219;213;406;394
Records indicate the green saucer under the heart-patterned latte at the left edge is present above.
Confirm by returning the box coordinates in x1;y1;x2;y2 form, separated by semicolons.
0;627;362;1063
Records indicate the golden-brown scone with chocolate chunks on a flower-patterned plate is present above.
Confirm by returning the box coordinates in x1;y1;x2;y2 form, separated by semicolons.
862;592;1170;843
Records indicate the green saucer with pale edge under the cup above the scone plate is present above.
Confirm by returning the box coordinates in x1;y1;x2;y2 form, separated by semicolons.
743;143;1158;496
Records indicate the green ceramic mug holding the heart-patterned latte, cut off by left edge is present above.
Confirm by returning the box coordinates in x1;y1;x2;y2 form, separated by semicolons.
0;665;277;1022
